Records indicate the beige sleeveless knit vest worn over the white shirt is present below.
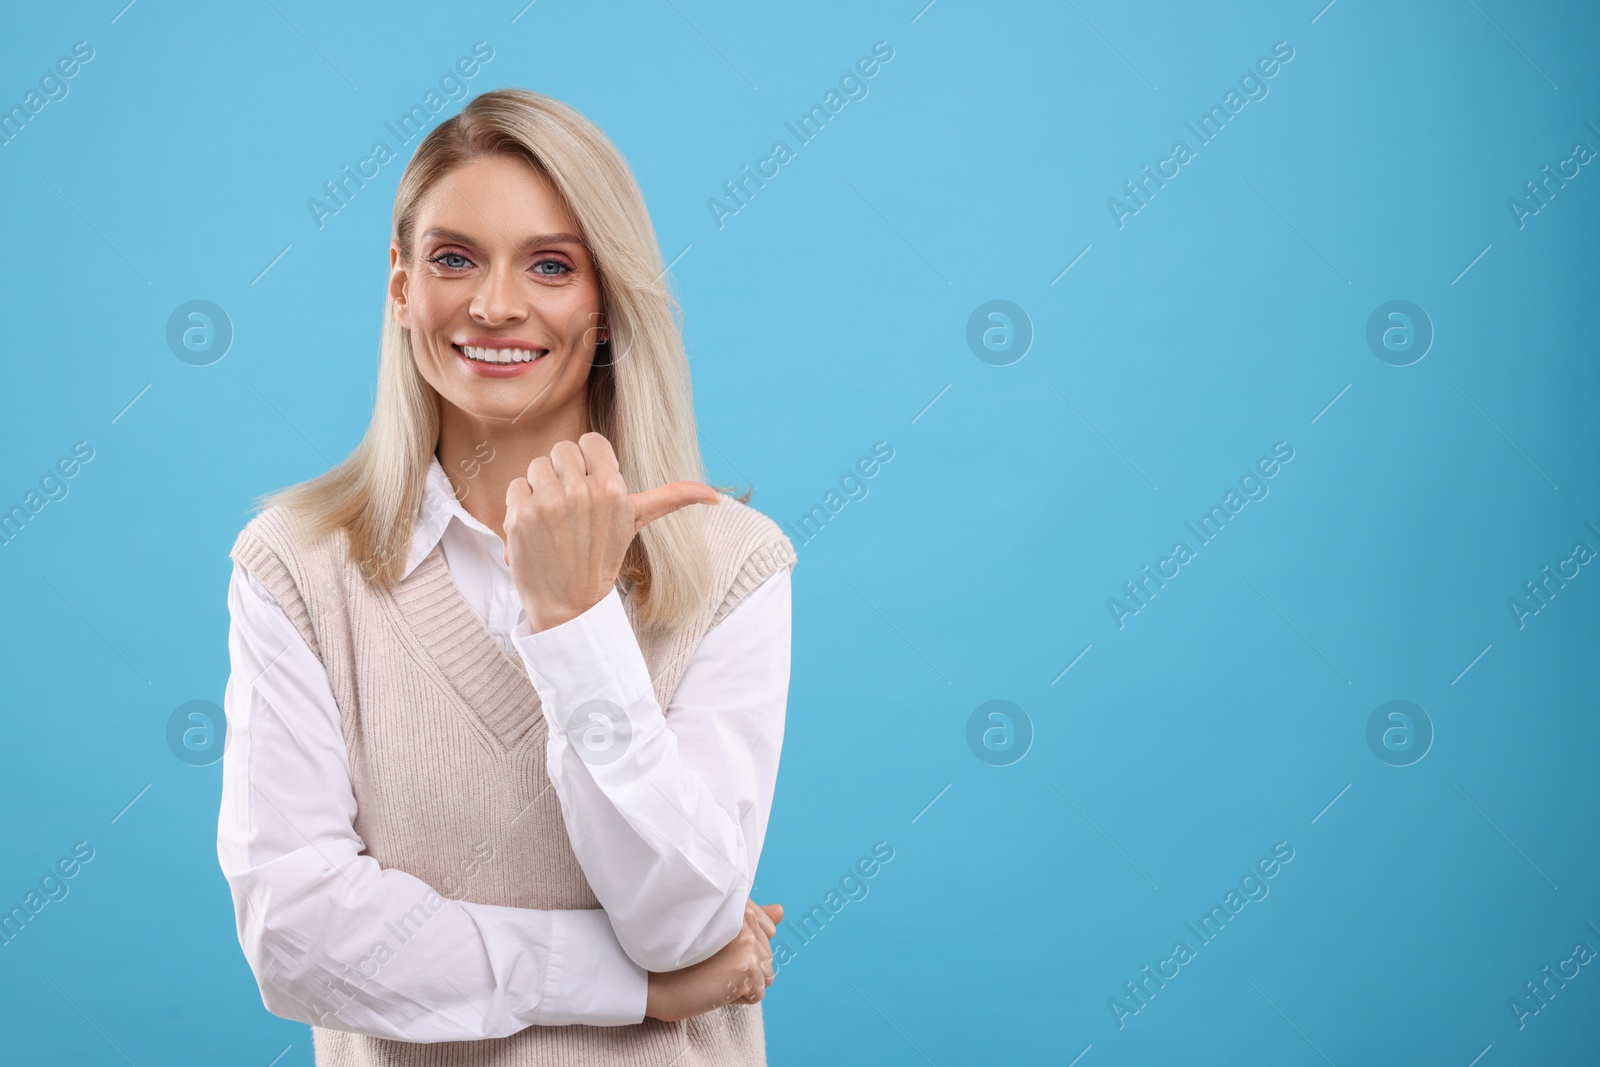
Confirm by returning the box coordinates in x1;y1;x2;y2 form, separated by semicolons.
230;496;795;1067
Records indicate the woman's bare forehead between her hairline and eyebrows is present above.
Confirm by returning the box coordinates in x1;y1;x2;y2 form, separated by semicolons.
416;155;579;245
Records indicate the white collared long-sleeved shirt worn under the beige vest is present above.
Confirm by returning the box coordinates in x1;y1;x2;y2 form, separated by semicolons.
218;458;790;1041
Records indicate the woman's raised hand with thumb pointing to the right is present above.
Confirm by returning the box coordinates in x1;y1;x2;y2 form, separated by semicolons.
504;430;720;633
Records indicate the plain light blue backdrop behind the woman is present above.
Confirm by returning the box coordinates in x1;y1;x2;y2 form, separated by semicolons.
0;0;1600;1067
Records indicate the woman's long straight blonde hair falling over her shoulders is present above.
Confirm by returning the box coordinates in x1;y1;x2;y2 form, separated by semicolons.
258;90;750;627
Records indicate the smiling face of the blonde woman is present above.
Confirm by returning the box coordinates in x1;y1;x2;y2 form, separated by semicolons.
389;155;606;430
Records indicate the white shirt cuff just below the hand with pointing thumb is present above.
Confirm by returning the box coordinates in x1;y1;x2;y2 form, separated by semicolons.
512;589;651;725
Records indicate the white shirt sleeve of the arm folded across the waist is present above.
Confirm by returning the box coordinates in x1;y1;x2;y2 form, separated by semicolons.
218;563;648;1041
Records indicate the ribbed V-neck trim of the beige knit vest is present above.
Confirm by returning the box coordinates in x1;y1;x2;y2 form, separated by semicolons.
382;542;546;750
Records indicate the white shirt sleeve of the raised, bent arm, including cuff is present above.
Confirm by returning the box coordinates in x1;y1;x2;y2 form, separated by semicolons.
512;568;790;971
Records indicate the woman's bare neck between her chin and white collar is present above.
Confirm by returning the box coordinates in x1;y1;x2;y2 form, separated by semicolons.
437;402;590;541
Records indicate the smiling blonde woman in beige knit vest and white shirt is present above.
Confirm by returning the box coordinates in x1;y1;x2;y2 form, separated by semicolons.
218;90;795;1067
